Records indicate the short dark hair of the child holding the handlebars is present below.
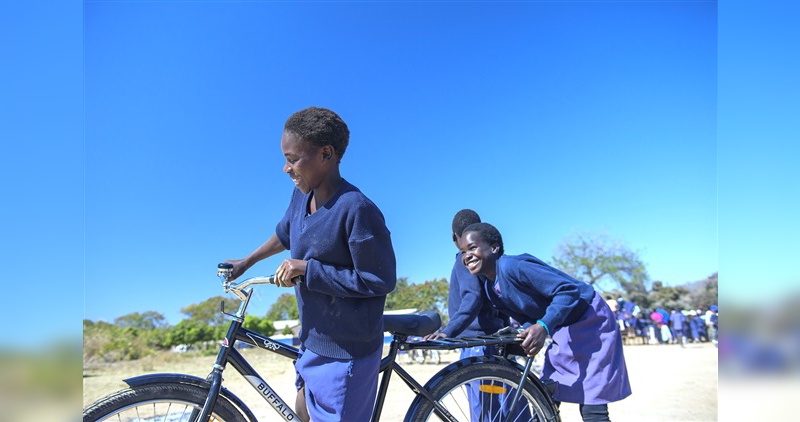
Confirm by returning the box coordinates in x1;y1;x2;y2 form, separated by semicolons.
283;107;350;159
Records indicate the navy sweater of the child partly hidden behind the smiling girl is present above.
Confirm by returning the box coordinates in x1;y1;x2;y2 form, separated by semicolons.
442;252;507;337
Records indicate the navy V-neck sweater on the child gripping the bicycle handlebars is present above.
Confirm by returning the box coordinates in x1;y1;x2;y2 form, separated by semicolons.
275;180;397;359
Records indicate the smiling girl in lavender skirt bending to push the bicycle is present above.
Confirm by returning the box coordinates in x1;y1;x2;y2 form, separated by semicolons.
459;223;631;421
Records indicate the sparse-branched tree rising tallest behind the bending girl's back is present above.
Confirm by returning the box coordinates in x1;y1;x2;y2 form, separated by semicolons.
553;232;648;300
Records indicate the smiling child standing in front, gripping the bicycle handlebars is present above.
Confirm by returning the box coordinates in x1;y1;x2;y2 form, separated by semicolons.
223;107;397;422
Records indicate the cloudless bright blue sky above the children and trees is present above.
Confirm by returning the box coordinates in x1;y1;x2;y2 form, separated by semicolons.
2;1;798;348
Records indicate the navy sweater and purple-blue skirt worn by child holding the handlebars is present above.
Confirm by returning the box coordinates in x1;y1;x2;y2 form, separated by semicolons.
275;180;397;421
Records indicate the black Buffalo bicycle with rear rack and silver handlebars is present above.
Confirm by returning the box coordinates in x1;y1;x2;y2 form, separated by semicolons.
83;264;560;422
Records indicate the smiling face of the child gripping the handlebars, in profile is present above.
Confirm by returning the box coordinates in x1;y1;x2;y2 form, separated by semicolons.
281;132;335;194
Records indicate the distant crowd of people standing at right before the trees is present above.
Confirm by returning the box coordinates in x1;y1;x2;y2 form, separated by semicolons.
606;297;719;347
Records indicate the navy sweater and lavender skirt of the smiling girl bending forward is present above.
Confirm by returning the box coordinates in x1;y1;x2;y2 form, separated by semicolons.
486;254;631;405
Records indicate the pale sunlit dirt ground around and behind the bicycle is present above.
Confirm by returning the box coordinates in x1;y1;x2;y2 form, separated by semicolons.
83;343;717;422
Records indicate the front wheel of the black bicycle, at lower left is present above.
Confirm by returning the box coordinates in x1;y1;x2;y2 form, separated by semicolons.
83;383;248;422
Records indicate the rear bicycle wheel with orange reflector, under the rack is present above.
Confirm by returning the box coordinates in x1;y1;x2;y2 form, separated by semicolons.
405;359;560;422
